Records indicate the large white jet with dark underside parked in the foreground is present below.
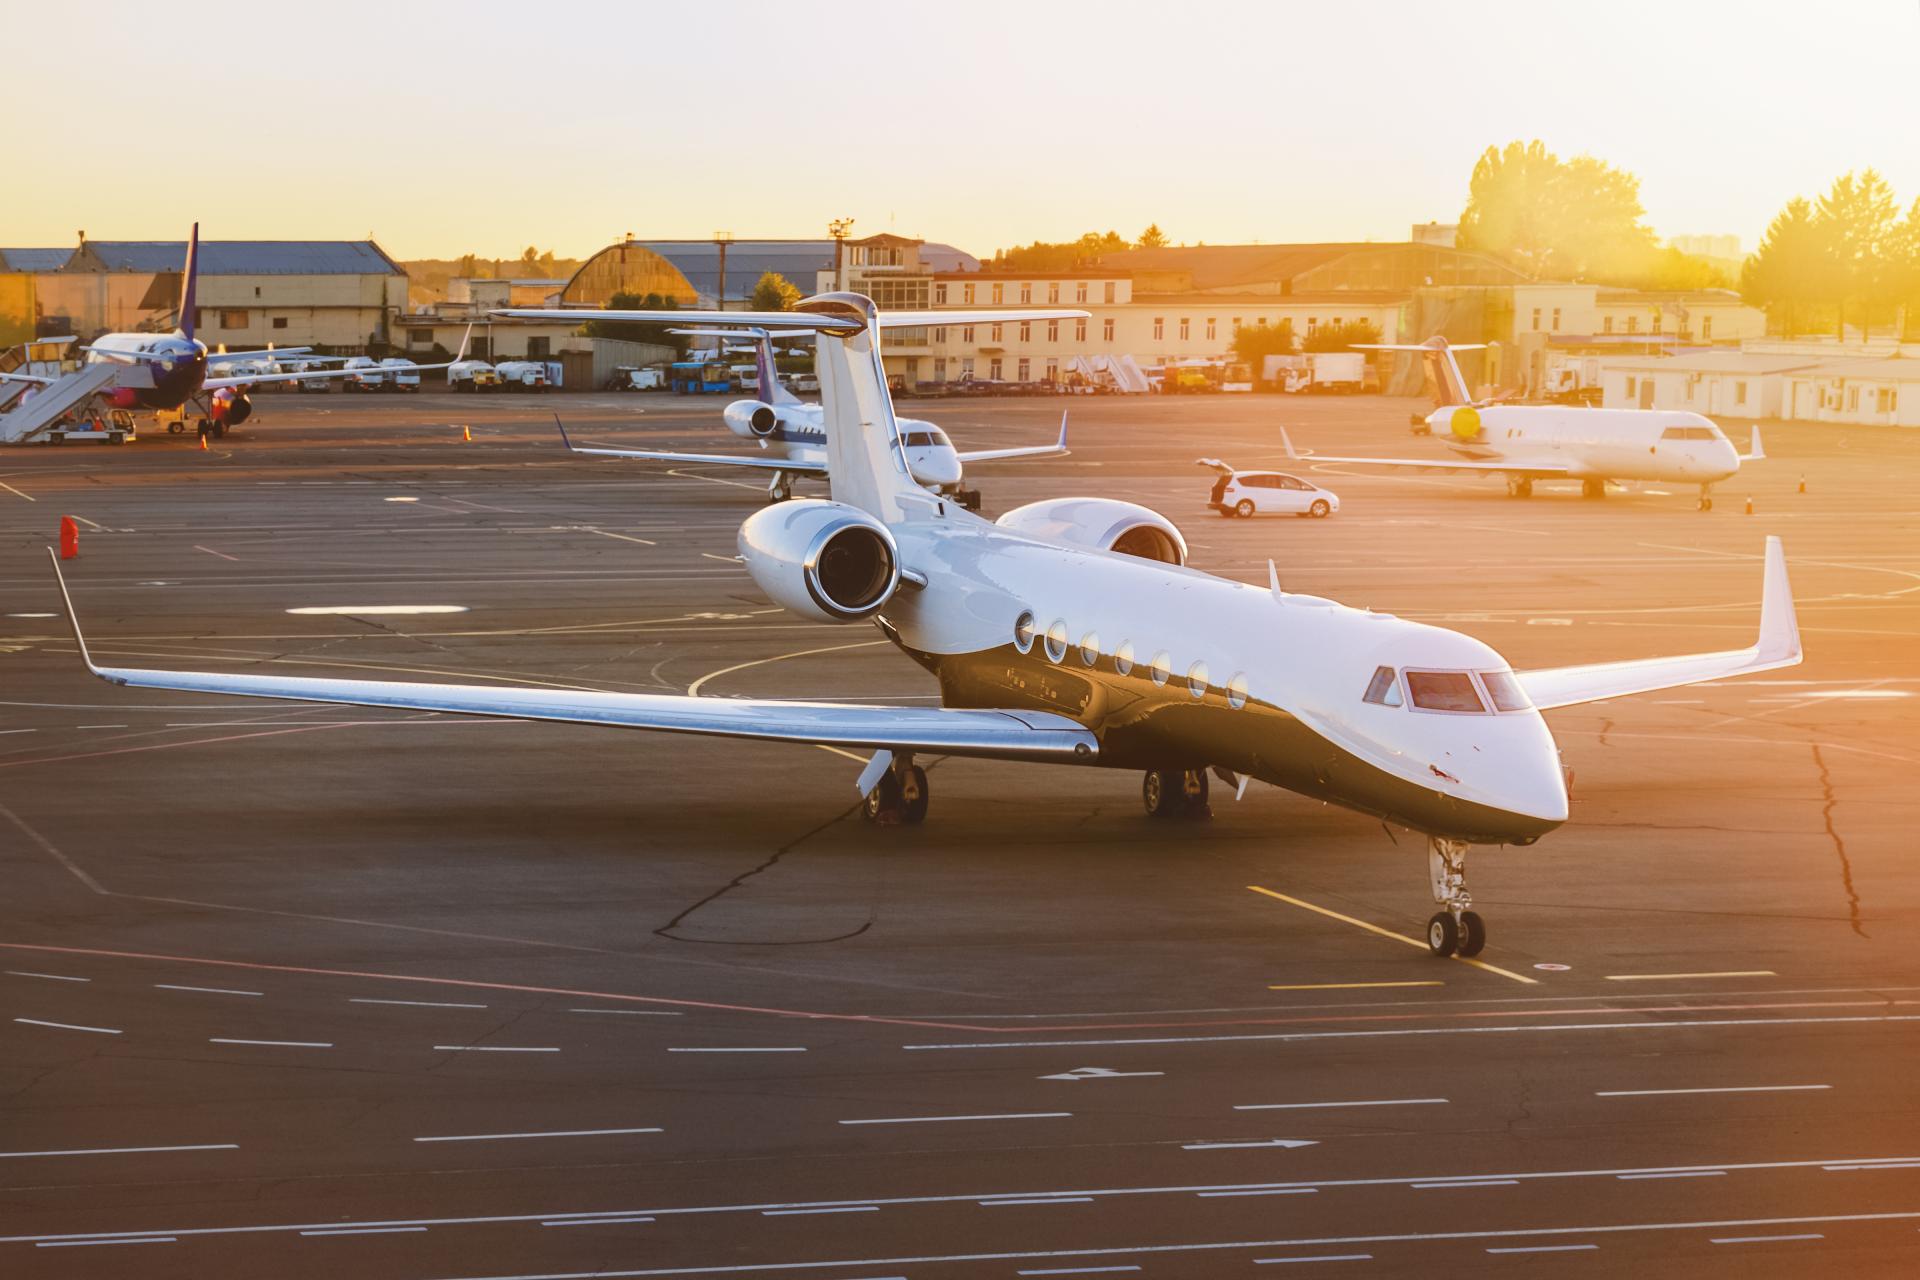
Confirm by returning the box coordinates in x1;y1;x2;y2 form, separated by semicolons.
48;294;1801;956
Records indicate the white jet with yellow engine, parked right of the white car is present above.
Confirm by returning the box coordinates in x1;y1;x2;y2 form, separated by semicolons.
1281;338;1766;510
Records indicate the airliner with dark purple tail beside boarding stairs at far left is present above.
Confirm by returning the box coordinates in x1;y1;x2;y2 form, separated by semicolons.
0;223;472;436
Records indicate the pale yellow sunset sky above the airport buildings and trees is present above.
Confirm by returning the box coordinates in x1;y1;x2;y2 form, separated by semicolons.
15;0;1920;257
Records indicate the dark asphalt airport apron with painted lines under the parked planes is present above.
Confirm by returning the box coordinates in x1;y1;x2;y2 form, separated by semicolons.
0;385;1920;1280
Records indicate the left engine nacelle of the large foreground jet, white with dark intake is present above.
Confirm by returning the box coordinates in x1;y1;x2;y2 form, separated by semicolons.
739;497;900;622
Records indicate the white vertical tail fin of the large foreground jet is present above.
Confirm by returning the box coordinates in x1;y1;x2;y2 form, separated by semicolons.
795;294;925;524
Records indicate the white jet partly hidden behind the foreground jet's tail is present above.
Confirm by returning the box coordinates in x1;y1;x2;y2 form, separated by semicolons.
533;318;1068;510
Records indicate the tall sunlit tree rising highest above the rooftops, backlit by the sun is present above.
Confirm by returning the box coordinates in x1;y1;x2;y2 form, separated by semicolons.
1459;138;1657;284
